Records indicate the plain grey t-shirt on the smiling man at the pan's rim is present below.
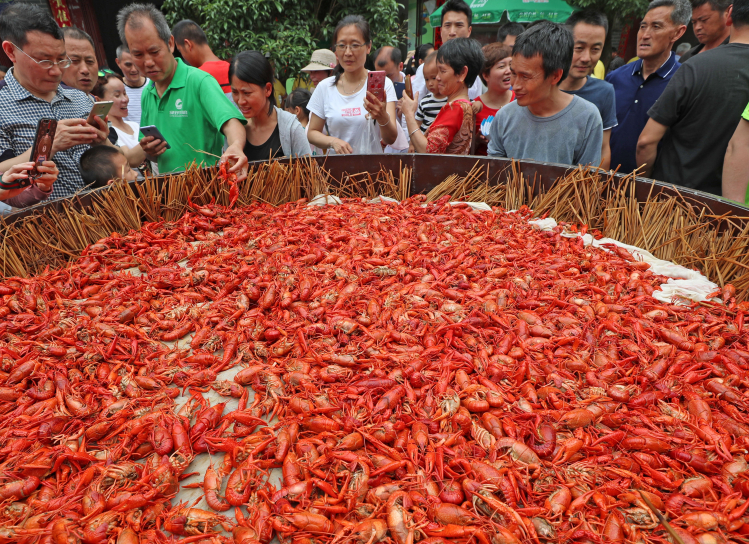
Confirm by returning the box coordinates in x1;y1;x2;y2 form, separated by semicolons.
489;96;603;166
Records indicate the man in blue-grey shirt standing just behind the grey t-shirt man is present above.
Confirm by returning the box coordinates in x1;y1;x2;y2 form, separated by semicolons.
559;11;617;170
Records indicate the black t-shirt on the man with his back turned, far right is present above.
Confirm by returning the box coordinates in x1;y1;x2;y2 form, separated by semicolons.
648;43;749;195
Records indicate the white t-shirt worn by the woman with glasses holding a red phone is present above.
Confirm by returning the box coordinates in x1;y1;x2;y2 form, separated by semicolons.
307;76;398;154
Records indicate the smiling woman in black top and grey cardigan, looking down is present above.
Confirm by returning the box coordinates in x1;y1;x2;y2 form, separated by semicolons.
229;51;312;161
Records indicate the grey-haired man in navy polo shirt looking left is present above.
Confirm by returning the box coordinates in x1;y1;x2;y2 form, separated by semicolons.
606;0;692;173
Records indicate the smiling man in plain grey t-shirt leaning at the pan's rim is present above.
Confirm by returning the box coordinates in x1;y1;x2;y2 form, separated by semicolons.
488;21;603;166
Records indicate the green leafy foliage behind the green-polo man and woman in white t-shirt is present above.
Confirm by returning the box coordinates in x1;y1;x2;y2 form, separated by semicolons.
162;0;405;81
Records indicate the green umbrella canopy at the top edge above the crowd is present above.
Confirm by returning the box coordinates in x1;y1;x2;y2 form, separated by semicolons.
429;0;575;27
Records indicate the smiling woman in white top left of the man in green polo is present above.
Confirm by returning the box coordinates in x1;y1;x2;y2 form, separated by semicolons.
93;73;146;168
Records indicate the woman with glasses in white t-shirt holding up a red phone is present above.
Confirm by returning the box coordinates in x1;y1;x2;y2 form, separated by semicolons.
307;15;398;154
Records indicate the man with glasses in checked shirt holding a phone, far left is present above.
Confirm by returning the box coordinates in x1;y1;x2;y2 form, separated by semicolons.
0;4;109;198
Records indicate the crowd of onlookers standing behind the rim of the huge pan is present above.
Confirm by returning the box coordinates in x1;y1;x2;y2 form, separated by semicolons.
0;0;749;211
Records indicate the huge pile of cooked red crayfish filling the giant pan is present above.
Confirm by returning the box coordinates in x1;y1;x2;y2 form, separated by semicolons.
0;196;749;544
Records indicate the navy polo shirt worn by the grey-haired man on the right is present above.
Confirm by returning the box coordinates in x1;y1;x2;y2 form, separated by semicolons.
606;52;681;174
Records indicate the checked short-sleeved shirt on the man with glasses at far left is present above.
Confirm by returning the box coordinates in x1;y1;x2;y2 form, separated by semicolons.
0;68;91;199
